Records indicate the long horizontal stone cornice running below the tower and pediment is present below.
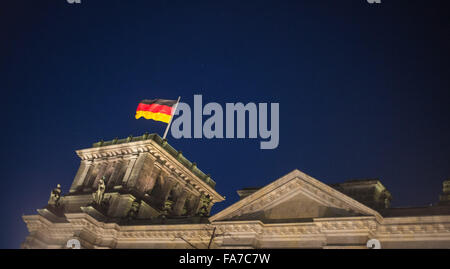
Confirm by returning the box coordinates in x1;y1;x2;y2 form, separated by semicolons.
23;213;450;242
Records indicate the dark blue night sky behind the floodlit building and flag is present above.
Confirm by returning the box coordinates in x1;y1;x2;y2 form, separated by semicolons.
0;0;450;248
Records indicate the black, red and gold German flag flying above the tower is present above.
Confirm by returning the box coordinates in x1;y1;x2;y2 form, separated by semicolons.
136;99;177;123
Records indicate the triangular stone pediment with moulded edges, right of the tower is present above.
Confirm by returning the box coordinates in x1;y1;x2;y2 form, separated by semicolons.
210;170;381;222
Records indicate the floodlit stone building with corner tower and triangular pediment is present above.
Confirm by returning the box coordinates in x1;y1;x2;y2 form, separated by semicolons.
22;134;450;248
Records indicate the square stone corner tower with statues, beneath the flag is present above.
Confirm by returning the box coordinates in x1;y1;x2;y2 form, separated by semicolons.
22;134;224;248
